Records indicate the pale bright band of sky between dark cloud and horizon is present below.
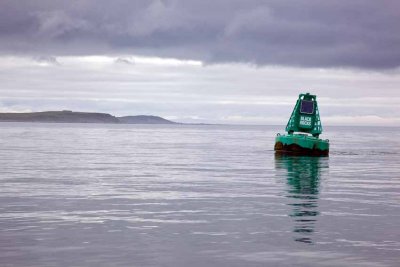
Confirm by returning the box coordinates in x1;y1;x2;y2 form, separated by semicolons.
0;55;400;126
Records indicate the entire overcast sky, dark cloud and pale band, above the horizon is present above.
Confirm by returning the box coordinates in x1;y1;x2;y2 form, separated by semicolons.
0;0;400;126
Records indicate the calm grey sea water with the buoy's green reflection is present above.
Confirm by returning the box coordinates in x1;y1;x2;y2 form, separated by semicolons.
0;123;400;267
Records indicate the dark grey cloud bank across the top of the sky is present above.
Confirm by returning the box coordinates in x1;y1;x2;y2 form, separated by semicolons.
0;0;400;69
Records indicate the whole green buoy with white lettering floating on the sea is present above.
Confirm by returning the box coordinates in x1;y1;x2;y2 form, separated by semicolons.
274;93;329;156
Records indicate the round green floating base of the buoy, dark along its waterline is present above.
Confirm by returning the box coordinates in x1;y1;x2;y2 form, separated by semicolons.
274;134;329;157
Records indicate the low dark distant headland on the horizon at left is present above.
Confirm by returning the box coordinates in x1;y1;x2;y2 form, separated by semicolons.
0;110;178;124
